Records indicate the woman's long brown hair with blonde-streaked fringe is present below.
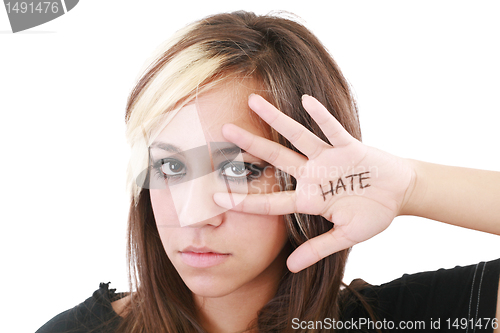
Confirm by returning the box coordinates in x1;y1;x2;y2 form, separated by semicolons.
120;12;361;333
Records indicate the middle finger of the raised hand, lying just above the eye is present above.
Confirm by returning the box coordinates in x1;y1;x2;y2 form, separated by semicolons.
222;124;307;178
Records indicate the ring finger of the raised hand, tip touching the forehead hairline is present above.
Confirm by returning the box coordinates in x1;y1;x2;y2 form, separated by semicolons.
248;94;330;158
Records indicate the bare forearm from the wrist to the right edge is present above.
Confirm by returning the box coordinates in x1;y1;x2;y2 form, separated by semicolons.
399;160;500;235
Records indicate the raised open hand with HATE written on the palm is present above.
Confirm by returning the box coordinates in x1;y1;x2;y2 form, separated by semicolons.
214;95;415;272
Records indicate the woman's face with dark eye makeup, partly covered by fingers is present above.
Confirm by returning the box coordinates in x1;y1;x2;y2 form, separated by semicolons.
150;80;287;297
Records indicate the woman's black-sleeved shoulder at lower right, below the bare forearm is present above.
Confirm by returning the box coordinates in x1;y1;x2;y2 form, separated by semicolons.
350;259;500;324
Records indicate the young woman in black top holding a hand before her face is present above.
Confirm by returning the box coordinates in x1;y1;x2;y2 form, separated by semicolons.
38;12;500;333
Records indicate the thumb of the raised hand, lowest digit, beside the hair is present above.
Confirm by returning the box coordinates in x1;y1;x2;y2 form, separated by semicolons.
287;229;355;273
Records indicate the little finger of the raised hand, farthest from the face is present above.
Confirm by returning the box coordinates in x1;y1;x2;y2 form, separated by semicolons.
302;95;355;146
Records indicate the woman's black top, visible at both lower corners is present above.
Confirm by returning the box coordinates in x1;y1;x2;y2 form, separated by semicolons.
36;259;500;333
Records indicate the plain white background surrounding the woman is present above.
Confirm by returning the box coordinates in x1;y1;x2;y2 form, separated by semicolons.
0;0;500;333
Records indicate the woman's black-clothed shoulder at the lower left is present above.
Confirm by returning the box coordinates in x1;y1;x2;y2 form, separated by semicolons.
36;283;124;333
